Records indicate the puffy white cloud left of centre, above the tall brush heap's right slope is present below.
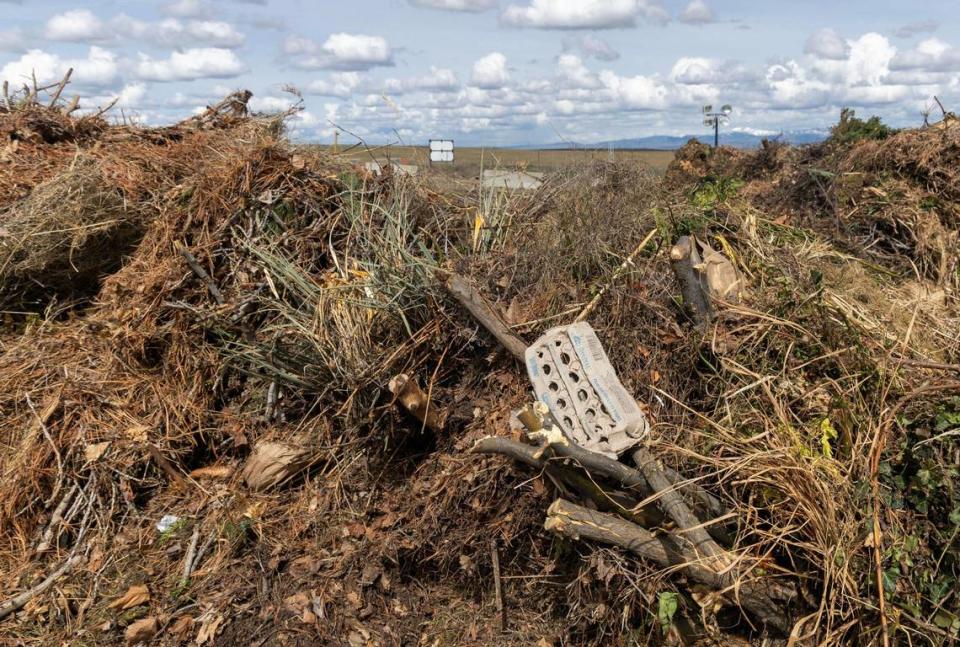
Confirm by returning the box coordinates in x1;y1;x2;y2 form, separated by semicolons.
283;33;394;71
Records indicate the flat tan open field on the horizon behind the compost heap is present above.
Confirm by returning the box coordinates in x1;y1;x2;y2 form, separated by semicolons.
316;146;674;177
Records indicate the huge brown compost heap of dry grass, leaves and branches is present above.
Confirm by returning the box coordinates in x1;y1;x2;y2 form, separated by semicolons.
0;93;960;646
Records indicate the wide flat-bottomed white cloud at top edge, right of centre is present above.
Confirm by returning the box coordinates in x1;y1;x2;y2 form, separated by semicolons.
500;0;670;29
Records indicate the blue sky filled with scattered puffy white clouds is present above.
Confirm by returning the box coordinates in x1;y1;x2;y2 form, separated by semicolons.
0;0;960;145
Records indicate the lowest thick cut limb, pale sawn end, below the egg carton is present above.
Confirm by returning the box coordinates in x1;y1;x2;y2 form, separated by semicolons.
544;499;793;632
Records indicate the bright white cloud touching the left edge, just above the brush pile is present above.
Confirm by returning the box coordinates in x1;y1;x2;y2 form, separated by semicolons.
0;47;119;87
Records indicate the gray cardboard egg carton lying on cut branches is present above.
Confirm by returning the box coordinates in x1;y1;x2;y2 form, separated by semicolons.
525;322;650;456
